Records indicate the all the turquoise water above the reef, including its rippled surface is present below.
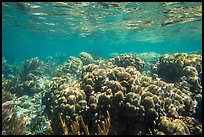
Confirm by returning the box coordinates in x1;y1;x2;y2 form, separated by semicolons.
2;3;202;62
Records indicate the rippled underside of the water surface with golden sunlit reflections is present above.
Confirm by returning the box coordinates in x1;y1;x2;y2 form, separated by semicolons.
2;2;202;43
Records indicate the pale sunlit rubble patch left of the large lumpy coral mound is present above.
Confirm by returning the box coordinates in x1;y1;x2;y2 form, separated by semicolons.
14;92;52;135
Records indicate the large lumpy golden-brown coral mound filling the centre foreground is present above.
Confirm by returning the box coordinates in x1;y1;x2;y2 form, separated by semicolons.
41;54;202;135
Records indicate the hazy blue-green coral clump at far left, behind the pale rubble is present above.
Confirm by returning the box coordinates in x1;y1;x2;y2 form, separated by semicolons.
3;58;47;96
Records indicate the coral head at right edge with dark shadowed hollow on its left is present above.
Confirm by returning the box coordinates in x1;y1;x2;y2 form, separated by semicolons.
152;53;202;82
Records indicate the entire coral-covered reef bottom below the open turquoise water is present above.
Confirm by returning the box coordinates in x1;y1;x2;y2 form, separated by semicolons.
2;52;202;135
